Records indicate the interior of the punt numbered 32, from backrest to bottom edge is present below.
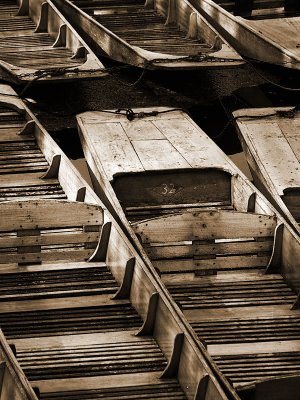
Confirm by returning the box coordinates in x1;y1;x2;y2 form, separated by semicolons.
132;209;300;400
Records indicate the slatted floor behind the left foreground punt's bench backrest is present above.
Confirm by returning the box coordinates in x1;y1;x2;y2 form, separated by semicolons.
0;108;66;201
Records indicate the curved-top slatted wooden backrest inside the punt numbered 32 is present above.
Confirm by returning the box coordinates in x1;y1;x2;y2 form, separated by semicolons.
133;210;276;274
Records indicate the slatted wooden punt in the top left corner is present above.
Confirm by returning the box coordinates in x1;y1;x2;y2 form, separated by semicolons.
0;0;107;84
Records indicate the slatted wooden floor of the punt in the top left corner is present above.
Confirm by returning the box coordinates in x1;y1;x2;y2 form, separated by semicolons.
0;0;85;70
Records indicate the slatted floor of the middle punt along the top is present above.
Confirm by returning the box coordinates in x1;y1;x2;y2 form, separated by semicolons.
73;0;211;56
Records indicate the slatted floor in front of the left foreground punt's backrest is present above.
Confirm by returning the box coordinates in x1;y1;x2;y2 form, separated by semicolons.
0;262;185;399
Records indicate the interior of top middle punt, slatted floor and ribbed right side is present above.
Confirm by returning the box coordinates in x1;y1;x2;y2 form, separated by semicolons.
68;0;234;57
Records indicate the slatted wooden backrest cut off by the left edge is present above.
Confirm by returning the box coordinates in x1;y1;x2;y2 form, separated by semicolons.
0;200;103;264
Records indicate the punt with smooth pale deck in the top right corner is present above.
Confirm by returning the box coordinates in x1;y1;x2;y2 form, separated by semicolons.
191;0;300;69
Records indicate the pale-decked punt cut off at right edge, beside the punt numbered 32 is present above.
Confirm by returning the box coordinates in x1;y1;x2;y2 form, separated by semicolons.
233;107;300;232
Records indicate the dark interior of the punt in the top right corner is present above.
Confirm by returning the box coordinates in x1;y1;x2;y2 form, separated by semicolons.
214;0;300;20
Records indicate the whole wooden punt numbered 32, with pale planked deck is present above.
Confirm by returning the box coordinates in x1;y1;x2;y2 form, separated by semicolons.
77;109;300;400
